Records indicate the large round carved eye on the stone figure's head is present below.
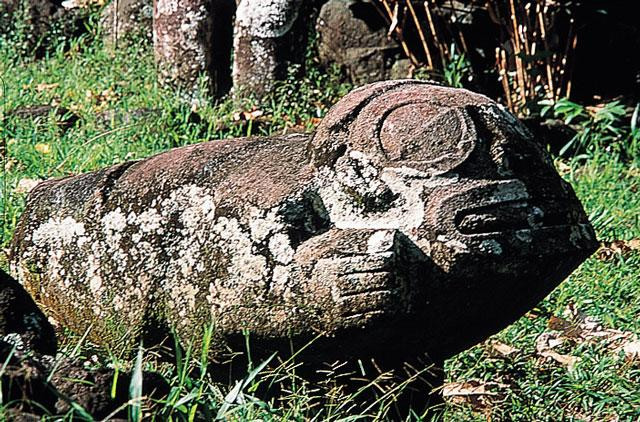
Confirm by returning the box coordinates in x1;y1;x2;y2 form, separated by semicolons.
379;103;476;175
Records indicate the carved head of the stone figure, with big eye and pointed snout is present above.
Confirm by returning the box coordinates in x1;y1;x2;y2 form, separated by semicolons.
312;81;597;356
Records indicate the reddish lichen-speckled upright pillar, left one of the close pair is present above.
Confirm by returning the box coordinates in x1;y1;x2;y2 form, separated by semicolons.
153;0;216;97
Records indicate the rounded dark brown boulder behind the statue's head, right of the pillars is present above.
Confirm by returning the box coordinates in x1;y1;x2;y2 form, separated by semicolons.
316;0;407;84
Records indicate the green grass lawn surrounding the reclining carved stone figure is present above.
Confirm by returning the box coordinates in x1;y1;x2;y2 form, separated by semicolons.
0;14;640;421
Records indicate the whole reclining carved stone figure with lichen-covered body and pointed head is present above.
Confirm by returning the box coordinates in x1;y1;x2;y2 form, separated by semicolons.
11;80;596;362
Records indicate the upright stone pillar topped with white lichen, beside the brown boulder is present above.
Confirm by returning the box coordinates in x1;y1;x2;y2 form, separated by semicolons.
233;0;302;98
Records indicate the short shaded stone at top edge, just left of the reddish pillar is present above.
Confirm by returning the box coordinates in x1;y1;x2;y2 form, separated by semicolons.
100;0;153;46
